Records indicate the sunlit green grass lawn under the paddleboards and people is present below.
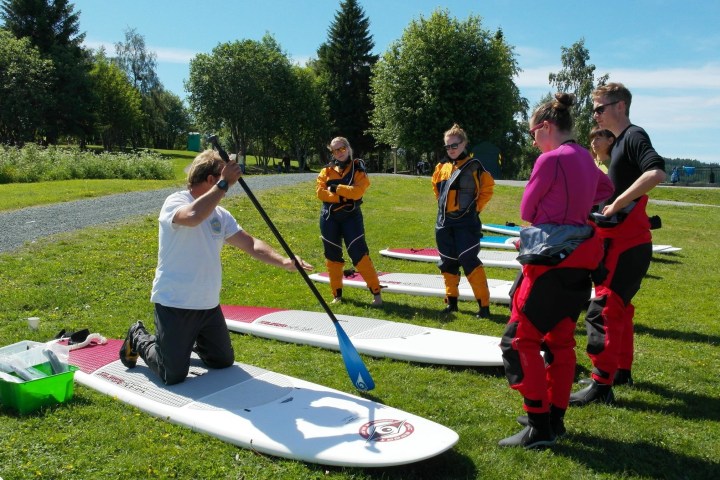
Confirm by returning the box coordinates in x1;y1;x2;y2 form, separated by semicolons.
0;176;720;480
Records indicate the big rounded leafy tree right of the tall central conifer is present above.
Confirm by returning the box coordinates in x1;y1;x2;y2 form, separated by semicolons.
371;10;526;165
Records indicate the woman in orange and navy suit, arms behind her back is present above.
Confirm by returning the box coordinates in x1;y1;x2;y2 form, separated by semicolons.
432;124;495;318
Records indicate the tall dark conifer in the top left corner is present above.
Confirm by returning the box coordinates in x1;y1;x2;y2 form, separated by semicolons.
0;0;92;143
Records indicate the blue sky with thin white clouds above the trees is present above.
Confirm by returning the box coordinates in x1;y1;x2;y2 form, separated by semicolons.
73;0;720;163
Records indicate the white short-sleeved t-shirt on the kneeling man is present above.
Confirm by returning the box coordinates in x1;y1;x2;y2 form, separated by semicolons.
150;191;242;310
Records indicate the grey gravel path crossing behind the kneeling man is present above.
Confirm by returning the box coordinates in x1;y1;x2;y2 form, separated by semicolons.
0;172;713;253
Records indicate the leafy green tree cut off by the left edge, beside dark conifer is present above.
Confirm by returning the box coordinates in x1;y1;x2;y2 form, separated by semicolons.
0;29;53;145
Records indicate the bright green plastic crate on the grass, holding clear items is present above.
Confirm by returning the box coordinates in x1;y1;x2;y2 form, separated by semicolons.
0;362;78;415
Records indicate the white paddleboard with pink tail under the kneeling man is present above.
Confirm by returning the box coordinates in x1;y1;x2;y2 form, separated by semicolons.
70;340;458;467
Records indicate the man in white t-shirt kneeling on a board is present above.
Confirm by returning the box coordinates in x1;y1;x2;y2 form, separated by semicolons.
120;150;312;385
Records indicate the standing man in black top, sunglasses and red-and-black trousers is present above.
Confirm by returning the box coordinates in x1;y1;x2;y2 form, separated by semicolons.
570;83;665;406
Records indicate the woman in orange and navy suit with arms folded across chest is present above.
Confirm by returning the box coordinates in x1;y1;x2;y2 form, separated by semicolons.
315;137;382;306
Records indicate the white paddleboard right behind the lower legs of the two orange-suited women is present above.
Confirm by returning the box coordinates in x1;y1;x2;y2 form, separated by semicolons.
310;272;513;304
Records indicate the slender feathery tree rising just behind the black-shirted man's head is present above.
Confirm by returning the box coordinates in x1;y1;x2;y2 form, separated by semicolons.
548;38;609;147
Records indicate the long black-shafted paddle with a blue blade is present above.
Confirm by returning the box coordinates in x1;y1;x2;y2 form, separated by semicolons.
208;135;375;391
